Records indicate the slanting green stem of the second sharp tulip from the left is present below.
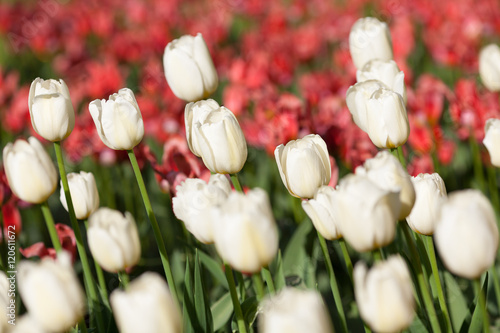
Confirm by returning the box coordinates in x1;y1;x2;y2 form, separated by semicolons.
127;149;179;304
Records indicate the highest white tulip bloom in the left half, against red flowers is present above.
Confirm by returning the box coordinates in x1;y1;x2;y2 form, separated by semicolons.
163;33;219;102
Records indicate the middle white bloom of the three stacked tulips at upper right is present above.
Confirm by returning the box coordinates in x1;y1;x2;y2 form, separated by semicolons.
356;59;406;102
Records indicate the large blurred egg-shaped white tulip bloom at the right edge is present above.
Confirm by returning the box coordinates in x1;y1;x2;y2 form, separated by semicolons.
434;190;498;279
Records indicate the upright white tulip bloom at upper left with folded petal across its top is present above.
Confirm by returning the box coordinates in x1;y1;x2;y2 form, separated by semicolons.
28;78;75;142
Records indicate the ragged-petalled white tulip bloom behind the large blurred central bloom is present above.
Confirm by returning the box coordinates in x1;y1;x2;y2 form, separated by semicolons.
172;174;231;244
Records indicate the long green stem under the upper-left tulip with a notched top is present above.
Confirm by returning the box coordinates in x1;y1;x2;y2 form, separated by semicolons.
54;141;104;332
